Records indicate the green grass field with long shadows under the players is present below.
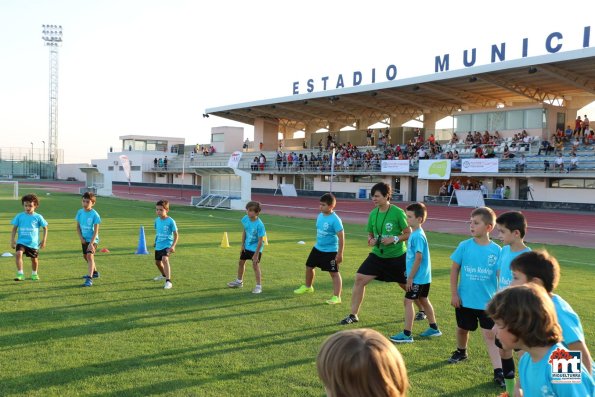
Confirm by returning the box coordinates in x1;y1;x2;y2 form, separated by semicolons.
0;187;595;397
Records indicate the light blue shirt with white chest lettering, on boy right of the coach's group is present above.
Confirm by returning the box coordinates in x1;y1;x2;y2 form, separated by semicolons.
450;238;501;310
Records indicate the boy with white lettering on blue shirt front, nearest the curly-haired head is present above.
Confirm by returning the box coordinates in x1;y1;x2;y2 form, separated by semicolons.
448;207;504;386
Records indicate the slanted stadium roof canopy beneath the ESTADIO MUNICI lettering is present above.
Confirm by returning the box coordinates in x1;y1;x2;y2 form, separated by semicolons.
205;47;595;130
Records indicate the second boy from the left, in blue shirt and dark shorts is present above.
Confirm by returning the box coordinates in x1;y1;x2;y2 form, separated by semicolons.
74;192;101;287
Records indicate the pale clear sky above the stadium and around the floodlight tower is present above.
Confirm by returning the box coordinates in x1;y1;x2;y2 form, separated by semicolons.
0;0;595;162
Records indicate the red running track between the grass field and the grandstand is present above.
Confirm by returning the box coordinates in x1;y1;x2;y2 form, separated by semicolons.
22;182;595;248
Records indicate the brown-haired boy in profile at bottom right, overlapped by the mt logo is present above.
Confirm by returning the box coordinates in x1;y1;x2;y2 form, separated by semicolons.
487;284;595;397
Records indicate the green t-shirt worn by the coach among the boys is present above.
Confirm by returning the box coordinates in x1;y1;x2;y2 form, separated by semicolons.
366;204;409;258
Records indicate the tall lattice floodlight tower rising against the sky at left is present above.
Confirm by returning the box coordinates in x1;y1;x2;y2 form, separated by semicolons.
41;25;62;165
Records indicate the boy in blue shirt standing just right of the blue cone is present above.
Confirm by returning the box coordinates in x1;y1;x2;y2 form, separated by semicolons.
154;200;178;289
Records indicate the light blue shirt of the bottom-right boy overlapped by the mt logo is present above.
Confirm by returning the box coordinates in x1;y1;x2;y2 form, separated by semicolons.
519;343;595;397
